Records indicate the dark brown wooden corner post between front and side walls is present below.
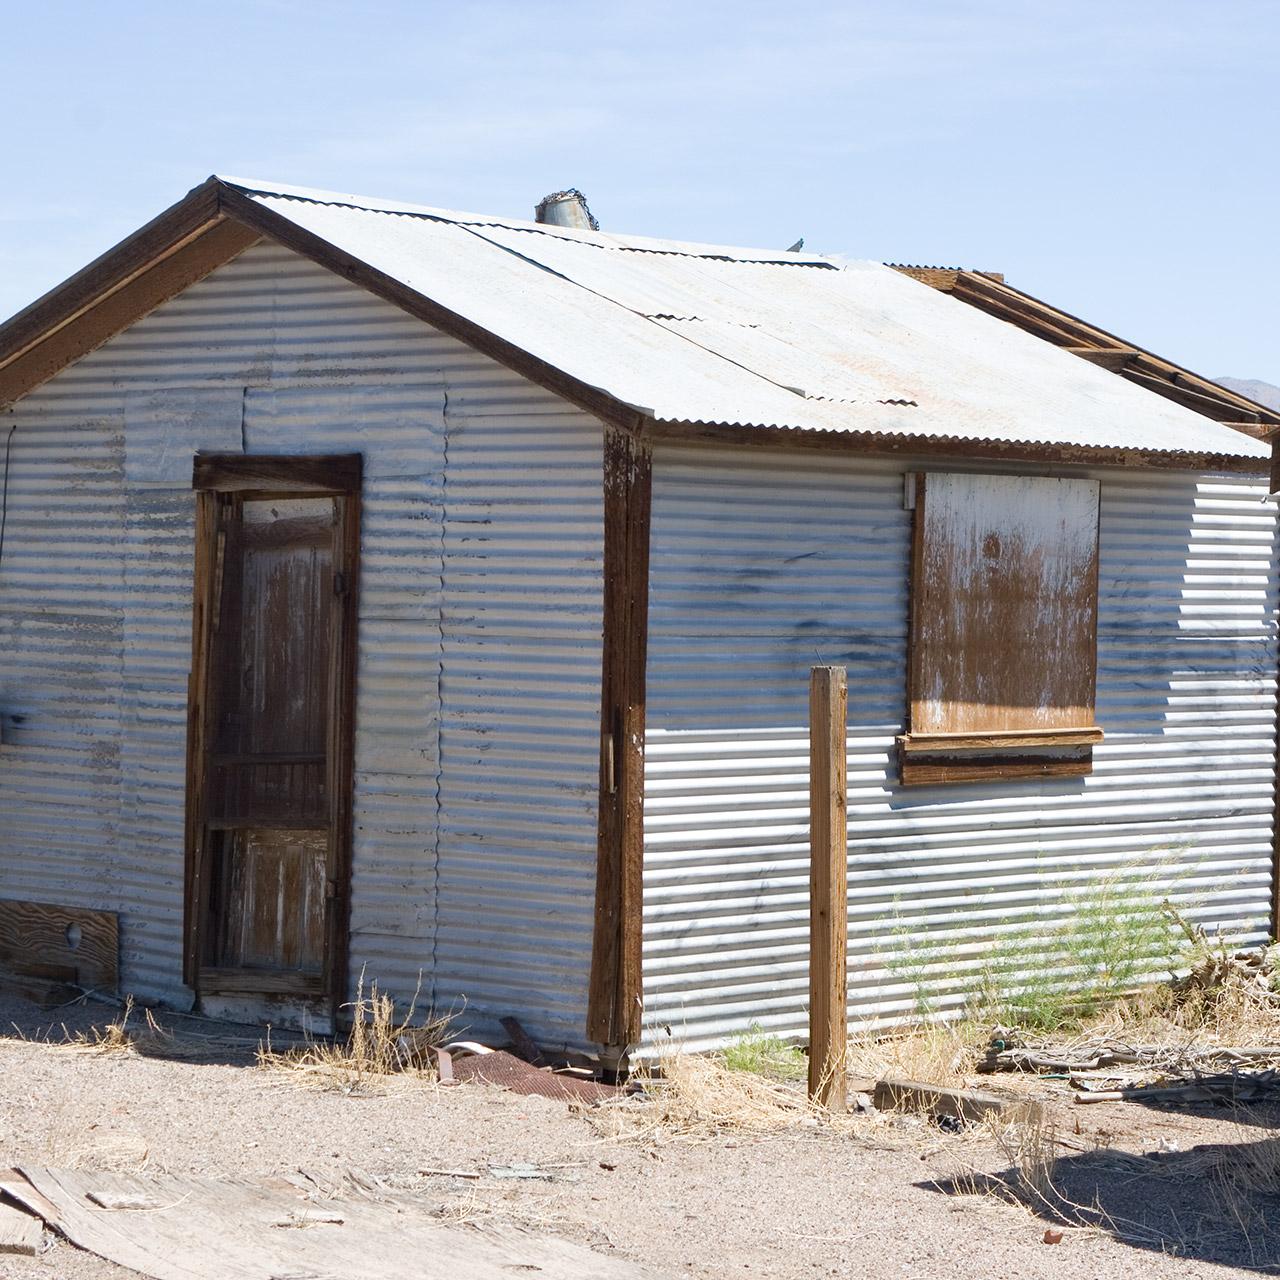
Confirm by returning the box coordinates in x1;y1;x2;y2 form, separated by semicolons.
586;428;652;1057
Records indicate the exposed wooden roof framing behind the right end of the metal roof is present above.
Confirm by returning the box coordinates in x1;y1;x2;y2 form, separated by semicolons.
891;262;1280;439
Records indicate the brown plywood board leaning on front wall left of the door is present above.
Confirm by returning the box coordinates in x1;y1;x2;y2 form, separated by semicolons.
0;899;120;993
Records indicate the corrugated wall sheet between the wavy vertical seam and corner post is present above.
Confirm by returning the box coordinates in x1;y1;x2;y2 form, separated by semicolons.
438;399;604;1043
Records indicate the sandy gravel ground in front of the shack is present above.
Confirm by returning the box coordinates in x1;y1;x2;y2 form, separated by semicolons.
0;997;1280;1280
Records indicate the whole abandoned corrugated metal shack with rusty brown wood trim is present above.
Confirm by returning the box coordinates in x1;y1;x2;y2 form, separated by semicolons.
0;179;1280;1048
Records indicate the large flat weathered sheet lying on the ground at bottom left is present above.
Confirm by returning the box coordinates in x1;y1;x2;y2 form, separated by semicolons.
3;1167;658;1280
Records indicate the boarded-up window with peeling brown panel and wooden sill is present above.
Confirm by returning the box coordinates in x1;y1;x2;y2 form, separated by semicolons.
899;472;1102;782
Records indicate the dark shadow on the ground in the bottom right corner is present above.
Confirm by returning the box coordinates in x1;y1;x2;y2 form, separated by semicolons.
916;1112;1280;1275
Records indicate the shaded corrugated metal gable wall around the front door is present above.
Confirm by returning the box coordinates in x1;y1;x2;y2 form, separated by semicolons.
0;244;602;1039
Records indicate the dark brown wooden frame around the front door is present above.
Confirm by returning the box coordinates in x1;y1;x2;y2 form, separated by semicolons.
183;453;364;1024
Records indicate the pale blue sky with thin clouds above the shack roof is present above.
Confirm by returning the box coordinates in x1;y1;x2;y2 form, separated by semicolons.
0;0;1280;383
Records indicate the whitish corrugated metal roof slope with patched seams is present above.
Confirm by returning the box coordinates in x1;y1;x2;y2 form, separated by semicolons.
221;178;1270;460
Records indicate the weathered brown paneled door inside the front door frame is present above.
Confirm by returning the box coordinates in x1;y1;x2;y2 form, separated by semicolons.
202;497;343;987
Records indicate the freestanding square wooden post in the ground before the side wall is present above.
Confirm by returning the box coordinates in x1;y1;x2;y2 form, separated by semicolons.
809;667;849;1111
